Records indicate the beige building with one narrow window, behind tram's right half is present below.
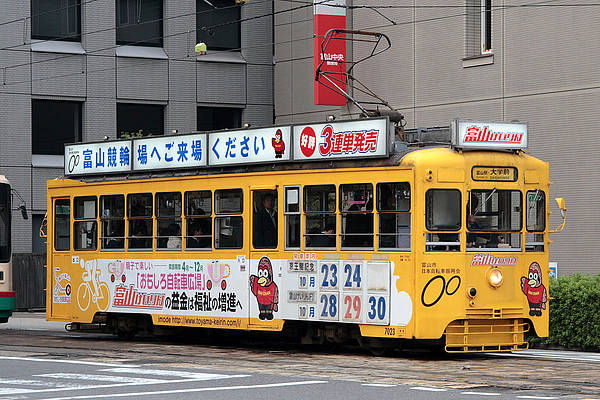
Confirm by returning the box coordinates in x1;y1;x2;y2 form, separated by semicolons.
274;0;600;275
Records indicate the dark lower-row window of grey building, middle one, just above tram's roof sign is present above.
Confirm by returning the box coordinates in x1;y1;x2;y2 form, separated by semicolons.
117;103;165;138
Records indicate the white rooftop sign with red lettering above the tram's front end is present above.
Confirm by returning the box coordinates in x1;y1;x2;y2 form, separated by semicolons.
452;120;529;150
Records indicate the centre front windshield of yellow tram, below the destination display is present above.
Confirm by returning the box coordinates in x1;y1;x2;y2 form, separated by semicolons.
467;189;523;251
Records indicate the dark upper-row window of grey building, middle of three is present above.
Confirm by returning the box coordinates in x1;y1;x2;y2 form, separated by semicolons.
116;0;163;47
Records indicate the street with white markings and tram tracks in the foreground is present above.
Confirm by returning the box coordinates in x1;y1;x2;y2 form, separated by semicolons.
0;318;600;400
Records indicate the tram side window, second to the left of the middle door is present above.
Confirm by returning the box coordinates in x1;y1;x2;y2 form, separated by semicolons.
185;190;212;250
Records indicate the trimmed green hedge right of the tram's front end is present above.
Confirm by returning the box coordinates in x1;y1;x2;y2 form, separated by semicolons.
530;274;600;350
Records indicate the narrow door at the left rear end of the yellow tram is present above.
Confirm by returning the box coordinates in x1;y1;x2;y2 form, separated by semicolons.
46;197;75;319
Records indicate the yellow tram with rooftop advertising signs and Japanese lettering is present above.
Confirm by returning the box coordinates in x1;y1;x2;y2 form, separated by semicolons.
46;117;566;352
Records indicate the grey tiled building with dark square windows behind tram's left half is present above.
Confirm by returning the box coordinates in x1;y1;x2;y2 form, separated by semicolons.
0;0;273;260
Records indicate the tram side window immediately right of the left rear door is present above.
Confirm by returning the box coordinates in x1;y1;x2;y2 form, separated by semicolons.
73;196;98;250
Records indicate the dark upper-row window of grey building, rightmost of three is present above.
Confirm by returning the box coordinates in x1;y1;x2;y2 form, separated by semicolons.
196;0;241;50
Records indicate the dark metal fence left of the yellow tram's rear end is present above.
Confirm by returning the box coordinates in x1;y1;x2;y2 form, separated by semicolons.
13;254;46;311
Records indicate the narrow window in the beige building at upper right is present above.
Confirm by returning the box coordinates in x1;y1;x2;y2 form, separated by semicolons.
465;0;492;57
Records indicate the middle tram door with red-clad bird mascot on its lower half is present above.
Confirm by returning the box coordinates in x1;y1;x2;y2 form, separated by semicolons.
248;186;284;326
